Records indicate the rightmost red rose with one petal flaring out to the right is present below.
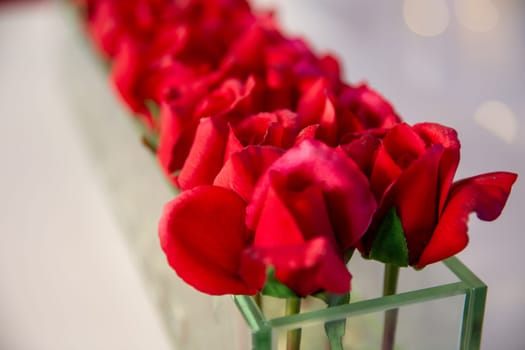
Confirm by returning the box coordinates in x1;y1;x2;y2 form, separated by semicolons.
342;123;516;267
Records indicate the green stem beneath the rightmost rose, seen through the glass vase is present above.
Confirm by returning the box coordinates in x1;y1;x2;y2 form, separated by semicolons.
381;264;399;350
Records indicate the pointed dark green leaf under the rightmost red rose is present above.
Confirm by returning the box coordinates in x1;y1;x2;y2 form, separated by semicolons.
370;208;408;266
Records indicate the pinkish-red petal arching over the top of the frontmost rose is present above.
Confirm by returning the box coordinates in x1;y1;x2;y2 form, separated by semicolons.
247;140;376;250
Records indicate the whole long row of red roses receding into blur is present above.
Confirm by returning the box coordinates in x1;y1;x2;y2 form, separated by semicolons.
76;0;516;296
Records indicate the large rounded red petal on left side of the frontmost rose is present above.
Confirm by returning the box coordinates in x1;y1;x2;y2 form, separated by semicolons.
159;186;264;295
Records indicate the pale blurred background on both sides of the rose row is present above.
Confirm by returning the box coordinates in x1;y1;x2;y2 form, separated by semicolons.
0;0;525;350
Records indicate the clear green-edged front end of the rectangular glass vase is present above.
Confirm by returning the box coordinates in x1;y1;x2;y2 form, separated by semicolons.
233;257;487;350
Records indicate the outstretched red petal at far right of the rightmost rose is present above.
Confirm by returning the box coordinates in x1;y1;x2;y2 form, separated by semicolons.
416;172;517;267
